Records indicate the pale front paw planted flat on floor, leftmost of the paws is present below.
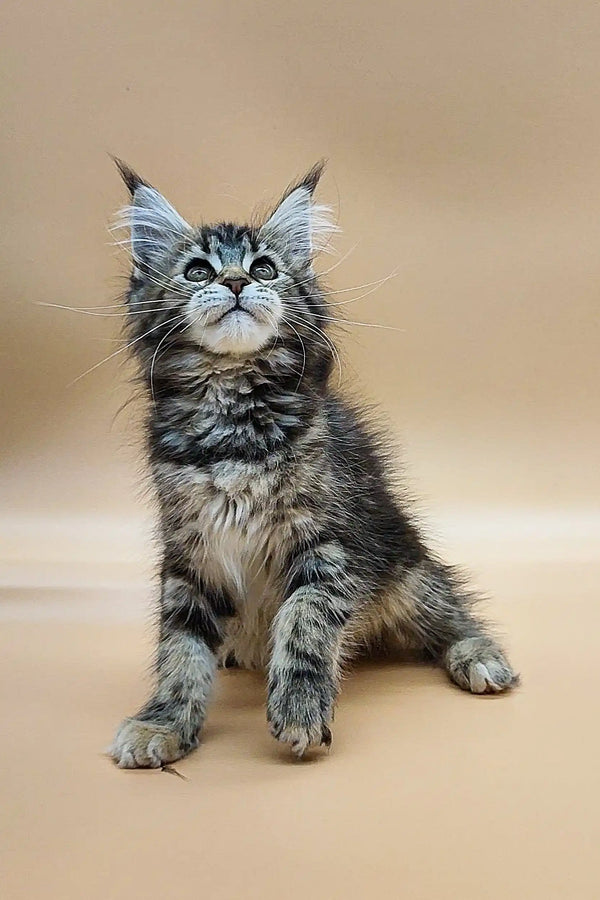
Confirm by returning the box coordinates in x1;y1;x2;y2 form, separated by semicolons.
108;719;192;769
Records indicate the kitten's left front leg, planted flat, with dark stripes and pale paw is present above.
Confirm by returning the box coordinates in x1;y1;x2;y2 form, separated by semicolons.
109;563;234;769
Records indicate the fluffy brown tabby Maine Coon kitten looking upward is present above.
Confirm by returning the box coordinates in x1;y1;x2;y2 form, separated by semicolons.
111;162;517;768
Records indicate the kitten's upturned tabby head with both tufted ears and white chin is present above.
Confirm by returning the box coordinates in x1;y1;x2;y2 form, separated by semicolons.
116;160;337;357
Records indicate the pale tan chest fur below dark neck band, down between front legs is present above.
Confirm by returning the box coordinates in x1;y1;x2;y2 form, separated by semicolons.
159;457;324;669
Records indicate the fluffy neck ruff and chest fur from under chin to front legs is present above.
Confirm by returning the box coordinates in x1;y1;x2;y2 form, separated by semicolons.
151;364;325;607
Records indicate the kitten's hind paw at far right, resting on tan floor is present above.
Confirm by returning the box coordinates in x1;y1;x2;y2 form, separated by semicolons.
444;637;519;694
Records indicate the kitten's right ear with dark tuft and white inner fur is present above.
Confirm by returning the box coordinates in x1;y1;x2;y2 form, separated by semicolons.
258;160;339;265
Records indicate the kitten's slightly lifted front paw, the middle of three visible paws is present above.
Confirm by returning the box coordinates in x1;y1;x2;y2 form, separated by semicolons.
267;680;334;758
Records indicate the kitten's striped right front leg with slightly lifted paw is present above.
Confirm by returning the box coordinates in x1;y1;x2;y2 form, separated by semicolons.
267;542;356;756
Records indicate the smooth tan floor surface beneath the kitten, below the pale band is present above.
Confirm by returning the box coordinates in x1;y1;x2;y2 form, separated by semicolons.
0;563;600;900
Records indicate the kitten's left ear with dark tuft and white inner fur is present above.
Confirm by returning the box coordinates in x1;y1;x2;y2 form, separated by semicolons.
114;159;191;265
